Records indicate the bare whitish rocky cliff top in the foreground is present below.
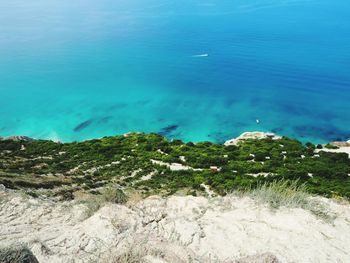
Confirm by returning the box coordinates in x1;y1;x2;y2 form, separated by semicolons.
0;191;350;263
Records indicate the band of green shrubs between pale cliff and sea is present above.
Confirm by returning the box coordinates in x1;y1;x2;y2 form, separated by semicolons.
0;133;350;200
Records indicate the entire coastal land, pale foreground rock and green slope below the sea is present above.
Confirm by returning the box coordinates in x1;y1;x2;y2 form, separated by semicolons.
0;132;350;263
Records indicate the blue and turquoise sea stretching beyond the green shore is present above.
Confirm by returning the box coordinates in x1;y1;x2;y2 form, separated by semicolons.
0;0;350;143
